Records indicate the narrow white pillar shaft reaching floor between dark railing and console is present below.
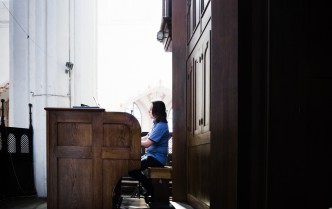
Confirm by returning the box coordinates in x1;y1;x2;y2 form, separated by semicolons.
29;0;48;197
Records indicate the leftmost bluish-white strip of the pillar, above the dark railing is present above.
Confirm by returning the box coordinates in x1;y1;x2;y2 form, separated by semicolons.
9;0;29;128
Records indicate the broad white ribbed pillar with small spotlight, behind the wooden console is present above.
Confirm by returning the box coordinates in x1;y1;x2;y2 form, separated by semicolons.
9;0;97;196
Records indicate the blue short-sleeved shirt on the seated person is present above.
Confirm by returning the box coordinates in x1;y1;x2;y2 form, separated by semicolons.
145;120;170;165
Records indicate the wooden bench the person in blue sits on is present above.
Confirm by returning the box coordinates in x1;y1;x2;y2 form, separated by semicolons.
146;166;174;208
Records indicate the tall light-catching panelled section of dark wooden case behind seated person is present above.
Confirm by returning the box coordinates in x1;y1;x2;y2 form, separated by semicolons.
187;0;211;208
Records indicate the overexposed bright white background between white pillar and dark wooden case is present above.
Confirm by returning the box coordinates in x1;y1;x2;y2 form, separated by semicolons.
97;0;172;111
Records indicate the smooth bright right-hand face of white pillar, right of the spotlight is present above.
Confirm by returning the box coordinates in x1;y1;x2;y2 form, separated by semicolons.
71;0;97;105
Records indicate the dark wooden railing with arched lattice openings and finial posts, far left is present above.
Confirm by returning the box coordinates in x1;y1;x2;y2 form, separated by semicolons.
0;99;36;199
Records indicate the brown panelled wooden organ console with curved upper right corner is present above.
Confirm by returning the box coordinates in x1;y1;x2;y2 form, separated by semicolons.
45;108;141;209
